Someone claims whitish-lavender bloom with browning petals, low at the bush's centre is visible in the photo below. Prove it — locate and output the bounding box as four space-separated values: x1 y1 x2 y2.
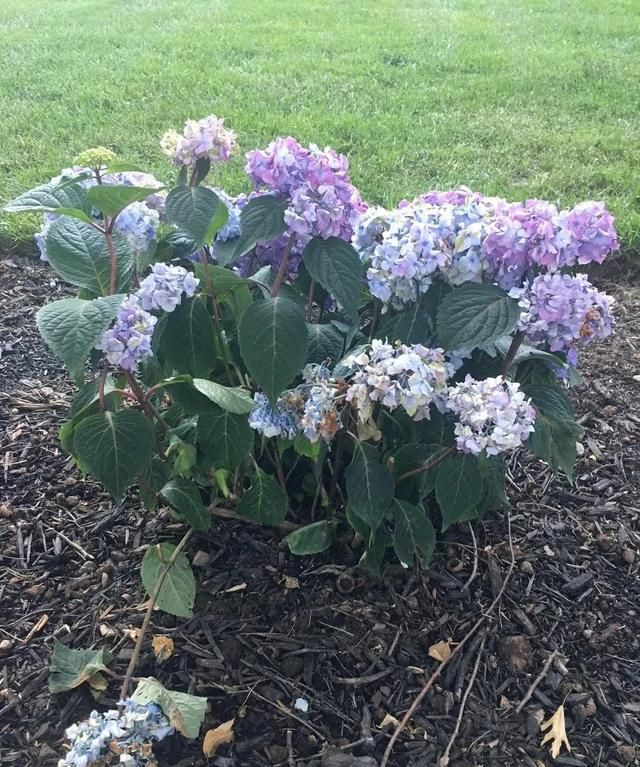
346 339 454 423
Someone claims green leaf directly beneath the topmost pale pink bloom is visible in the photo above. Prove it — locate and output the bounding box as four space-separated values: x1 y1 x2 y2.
166 186 229 247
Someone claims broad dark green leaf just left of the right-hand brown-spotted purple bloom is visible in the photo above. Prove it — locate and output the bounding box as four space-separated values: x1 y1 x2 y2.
438 282 520 349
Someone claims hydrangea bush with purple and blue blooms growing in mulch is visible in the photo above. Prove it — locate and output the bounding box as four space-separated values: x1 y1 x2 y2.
7 115 618 592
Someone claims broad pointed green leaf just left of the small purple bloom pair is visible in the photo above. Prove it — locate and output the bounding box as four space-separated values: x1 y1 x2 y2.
36 295 124 378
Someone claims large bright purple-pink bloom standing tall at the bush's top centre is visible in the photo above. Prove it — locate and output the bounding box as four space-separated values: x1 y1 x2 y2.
246 137 366 245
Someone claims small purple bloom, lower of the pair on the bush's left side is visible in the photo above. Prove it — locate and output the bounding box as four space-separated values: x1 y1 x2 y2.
96 295 157 371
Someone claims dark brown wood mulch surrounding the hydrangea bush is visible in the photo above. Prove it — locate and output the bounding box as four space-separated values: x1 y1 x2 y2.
0 255 640 767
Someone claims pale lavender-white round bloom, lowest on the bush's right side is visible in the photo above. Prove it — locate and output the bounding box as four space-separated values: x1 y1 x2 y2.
446 375 536 455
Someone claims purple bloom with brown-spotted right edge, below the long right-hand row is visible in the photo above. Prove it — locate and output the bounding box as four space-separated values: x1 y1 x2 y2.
511 272 615 365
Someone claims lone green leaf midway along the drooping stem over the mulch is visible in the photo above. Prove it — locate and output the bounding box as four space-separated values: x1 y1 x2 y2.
140 543 196 618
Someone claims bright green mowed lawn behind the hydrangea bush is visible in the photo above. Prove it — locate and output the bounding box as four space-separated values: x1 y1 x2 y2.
0 0 640 249
